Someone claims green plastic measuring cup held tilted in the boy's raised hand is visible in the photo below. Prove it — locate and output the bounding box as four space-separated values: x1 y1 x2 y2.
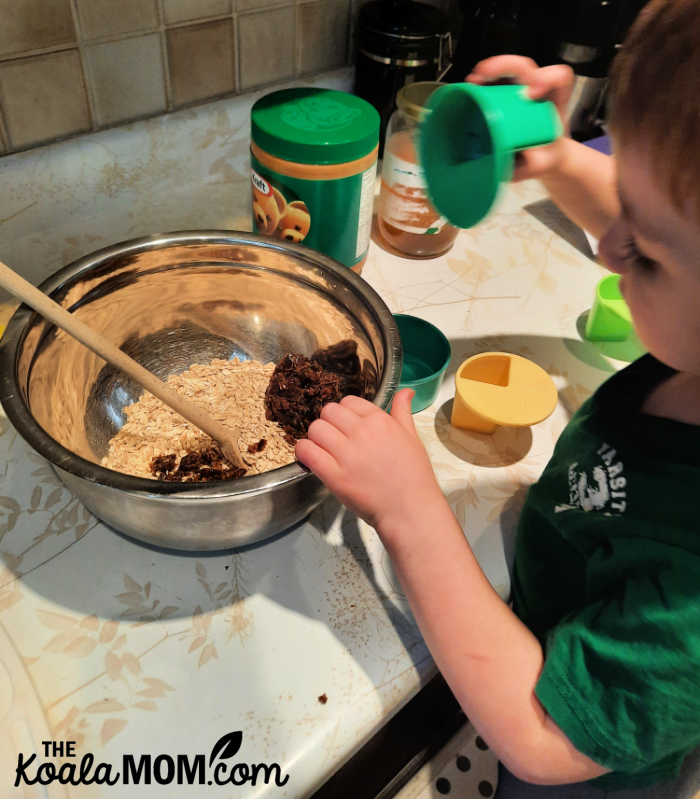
419 83 562 228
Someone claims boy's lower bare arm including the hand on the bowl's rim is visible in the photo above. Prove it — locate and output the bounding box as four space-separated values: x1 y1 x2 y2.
296 390 607 784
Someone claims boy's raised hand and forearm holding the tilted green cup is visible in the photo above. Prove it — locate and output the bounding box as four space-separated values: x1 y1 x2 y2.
467 55 619 239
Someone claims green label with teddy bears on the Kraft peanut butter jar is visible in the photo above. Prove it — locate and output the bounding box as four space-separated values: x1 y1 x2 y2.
250 156 377 267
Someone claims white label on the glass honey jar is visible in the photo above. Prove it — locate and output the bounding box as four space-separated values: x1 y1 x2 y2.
379 148 448 236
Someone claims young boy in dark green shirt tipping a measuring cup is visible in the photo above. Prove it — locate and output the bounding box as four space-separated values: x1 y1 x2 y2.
297 0 700 786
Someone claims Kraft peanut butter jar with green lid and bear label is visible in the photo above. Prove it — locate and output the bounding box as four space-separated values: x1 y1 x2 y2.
250 88 379 272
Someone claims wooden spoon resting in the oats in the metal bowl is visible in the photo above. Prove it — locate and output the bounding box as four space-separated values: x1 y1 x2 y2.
0 261 248 470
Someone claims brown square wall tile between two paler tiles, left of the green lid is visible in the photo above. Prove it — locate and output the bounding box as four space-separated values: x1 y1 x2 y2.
166 19 235 105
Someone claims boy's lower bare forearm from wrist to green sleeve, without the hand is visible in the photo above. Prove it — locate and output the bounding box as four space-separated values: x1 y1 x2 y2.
378 495 608 784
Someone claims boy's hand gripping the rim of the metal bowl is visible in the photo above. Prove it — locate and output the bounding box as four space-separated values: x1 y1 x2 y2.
296 389 442 528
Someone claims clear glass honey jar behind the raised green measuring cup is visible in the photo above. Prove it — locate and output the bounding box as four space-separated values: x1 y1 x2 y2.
377 81 459 258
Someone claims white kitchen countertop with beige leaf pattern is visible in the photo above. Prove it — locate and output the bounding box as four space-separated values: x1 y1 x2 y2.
0 76 619 797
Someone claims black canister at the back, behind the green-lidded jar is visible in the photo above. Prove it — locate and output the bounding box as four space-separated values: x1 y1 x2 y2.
354 0 450 154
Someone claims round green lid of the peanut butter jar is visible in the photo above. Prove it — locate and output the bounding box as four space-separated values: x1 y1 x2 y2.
251 88 379 164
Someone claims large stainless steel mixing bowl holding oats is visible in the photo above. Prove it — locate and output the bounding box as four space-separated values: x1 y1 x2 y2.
0 231 401 550
